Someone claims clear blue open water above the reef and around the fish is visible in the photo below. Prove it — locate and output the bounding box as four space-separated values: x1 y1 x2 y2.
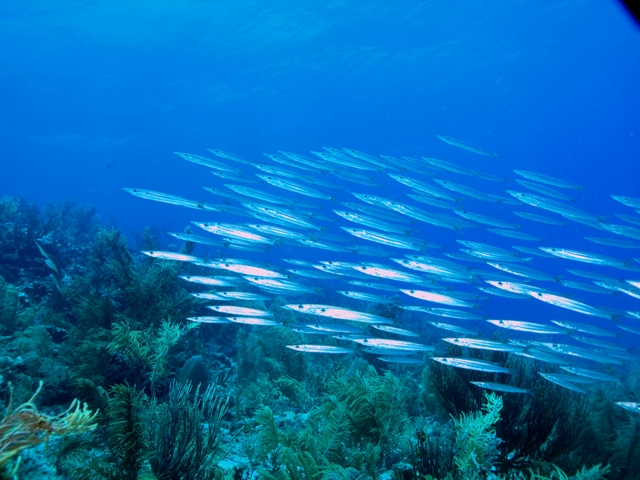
0 0 640 478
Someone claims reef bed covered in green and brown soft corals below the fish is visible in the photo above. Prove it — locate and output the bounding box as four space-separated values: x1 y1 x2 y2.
0 193 640 480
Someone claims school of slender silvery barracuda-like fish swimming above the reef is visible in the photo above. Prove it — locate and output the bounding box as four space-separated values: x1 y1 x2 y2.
124 136 640 413
